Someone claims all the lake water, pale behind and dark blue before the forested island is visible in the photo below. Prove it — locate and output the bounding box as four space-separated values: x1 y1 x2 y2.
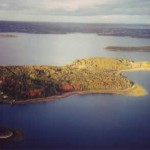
0 33 150 150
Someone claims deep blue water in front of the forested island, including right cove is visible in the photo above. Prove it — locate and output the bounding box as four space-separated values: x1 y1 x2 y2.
0 72 150 150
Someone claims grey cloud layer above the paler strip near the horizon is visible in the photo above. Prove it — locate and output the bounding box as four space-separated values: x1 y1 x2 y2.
0 0 150 16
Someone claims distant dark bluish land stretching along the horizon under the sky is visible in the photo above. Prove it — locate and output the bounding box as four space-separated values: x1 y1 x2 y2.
0 21 150 38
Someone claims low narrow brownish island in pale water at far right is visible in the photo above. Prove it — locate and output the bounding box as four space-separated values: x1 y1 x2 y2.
105 46 150 52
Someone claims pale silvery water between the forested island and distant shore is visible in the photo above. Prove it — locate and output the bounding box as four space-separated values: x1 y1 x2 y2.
0 33 150 65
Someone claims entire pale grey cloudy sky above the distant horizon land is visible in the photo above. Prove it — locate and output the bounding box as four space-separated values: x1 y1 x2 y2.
0 0 150 24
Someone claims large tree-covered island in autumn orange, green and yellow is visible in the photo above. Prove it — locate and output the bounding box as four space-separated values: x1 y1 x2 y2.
0 58 150 104
